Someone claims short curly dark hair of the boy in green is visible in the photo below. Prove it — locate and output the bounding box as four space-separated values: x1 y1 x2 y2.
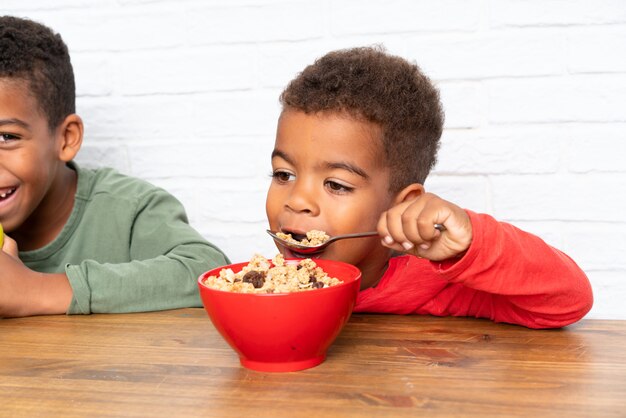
0 16 76 130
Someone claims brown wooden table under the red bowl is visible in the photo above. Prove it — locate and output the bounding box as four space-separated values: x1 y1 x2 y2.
0 309 626 418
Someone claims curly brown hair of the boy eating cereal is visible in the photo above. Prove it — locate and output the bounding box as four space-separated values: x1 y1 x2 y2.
280 47 444 193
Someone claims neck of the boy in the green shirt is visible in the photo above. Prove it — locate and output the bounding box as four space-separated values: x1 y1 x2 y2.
11 164 77 251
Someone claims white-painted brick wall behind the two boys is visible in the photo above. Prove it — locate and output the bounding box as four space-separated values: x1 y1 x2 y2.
0 0 626 319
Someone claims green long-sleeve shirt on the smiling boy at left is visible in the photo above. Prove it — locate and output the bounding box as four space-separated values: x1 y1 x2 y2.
19 163 229 314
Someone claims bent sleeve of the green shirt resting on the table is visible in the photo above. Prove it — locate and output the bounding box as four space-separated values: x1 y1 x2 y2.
65 189 229 314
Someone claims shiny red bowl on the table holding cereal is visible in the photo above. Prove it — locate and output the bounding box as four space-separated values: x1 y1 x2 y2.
198 259 361 372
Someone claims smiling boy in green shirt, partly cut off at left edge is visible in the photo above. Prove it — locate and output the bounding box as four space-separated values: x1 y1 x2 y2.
0 16 229 317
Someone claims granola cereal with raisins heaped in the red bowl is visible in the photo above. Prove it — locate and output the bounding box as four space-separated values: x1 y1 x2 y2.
204 254 343 293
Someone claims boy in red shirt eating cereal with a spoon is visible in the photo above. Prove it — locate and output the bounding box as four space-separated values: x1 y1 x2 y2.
266 48 593 328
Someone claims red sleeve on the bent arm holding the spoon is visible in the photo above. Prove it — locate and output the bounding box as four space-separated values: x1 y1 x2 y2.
418 211 593 328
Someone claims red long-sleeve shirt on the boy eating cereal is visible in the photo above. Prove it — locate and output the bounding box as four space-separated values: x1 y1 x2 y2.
354 211 593 328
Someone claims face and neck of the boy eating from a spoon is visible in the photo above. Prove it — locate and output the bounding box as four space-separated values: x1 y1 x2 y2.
266 110 393 288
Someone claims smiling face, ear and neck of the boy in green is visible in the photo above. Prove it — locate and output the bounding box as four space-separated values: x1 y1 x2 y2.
0 78 82 249
